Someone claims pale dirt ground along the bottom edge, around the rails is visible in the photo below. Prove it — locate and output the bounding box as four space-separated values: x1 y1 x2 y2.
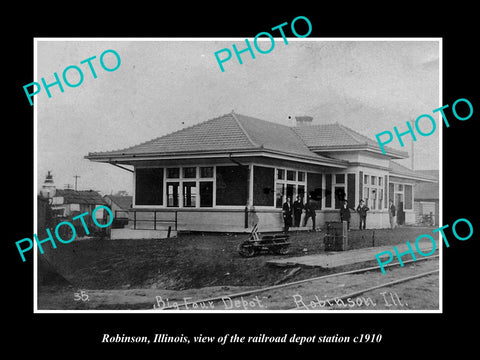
39 258 439 311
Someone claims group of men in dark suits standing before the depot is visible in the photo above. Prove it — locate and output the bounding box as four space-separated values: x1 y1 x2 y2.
282 196 396 232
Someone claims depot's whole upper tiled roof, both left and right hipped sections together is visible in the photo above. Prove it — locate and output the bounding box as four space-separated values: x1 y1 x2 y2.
86 112 408 164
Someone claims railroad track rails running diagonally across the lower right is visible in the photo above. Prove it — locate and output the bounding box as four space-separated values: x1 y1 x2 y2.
160 255 439 310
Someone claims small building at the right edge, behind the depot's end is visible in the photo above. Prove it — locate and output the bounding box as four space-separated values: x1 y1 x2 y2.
414 170 440 226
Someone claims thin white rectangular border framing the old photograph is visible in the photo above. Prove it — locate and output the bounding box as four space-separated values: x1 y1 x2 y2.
33 37 443 314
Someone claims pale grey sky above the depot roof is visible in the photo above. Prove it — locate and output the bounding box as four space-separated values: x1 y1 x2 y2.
36 38 442 194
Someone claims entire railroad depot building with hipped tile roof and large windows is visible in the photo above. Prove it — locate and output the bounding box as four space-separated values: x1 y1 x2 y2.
85 112 436 237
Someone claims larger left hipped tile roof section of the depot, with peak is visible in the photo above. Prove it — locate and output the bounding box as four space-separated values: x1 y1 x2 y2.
86 112 342 163
